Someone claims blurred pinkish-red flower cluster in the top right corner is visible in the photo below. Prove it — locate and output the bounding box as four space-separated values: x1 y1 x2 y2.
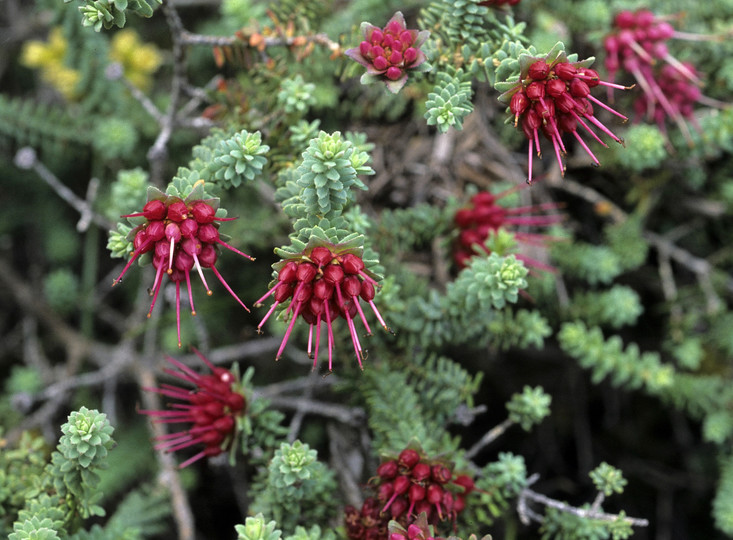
603 9 701 140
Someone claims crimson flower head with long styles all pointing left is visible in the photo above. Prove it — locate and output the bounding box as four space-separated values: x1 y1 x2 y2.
140 349 247 468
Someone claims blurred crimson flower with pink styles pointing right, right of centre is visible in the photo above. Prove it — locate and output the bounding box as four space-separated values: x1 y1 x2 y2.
453 186 564 271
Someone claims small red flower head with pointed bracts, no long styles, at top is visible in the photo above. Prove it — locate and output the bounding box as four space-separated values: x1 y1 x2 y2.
344 11 430 93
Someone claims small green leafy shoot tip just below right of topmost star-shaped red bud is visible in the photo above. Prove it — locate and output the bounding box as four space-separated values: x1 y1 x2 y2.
425 69 473 133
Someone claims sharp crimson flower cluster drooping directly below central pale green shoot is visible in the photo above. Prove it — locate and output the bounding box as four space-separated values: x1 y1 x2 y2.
255 245 389 371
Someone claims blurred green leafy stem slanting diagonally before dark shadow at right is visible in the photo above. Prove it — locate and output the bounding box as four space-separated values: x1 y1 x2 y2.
557 322 675 394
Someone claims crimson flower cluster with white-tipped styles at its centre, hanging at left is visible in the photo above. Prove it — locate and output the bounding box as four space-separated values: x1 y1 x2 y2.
113 197 252 347
